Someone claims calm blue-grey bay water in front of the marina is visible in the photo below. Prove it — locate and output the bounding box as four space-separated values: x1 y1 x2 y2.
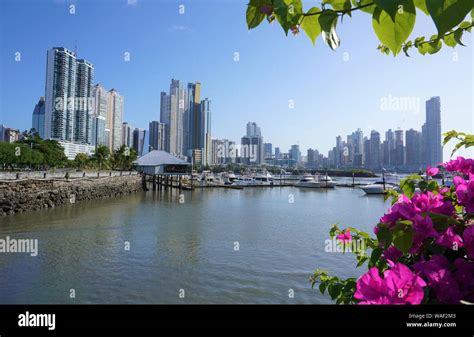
0 187 389 303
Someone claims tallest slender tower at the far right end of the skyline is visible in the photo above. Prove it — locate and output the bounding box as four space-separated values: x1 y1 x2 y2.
422 97 443 166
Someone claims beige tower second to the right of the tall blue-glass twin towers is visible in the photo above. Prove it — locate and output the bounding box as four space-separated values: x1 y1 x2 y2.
106 89 124 150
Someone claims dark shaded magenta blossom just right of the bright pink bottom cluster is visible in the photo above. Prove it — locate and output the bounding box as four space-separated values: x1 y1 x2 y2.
413 255 461 304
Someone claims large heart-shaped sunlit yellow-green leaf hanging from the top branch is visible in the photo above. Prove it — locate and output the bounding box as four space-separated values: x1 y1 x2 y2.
372 0 416 55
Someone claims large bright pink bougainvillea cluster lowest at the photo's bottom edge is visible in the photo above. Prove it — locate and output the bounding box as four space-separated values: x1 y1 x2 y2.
354 263 426 304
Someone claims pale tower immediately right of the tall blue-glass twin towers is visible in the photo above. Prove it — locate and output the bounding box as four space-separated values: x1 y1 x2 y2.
92 84 110 146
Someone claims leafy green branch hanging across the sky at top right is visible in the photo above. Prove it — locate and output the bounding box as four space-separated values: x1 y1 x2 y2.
246 0 474 56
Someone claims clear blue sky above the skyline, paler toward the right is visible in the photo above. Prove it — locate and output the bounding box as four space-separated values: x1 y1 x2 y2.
0 0 474 157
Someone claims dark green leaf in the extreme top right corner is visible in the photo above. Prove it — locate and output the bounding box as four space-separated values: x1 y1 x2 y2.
426 0 474 36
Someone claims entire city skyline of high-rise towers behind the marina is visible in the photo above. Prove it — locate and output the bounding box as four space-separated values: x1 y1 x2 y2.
0 47 443 172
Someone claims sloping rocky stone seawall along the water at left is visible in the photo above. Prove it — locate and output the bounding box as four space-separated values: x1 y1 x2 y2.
0 175 143 216
